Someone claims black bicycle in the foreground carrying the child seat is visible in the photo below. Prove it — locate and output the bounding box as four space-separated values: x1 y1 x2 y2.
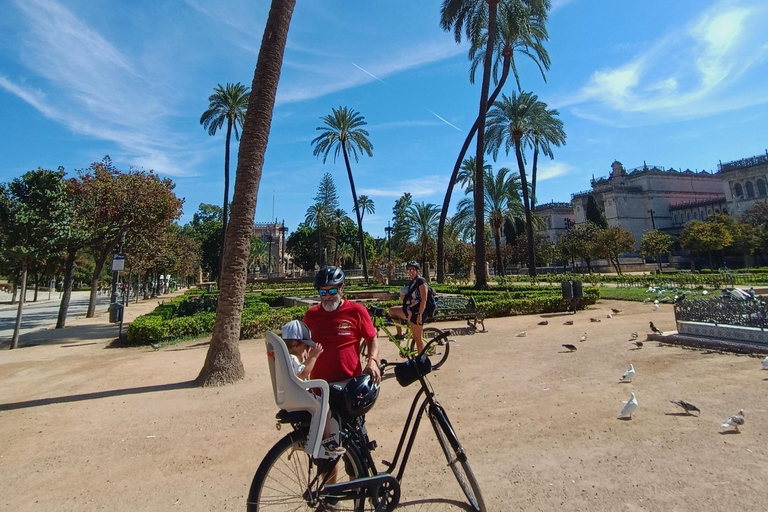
248 333 486 512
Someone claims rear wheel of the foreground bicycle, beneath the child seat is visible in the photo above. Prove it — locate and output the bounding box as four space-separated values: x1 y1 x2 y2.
247 430 374 512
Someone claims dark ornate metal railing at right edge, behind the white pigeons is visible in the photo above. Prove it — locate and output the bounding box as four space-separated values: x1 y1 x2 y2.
675 297 768 330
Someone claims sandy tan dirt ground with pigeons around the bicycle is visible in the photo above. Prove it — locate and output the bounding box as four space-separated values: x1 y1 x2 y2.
0 301 768 512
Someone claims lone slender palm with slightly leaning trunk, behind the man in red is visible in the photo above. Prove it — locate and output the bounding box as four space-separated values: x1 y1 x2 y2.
312 107 373 284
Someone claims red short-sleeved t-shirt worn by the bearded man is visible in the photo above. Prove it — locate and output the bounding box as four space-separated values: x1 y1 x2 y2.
304 300 376 382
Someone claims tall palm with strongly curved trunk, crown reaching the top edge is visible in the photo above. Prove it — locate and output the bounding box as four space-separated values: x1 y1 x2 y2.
437 0 551 282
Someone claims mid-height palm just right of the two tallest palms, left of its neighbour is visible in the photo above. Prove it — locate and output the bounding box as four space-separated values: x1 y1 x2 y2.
487 92 538 276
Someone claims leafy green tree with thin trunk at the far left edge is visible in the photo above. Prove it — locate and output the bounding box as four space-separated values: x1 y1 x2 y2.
0 167 72 349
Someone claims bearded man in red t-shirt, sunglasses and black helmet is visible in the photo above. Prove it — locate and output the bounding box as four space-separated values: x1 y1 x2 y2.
304 266 381 384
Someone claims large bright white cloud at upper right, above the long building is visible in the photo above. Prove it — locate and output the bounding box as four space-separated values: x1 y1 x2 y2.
559 0 768 125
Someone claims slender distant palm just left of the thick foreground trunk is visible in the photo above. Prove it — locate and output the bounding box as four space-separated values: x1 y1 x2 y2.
200 82 250 276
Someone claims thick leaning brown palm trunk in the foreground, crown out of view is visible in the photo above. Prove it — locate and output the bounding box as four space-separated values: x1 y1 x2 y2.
195 0 296 386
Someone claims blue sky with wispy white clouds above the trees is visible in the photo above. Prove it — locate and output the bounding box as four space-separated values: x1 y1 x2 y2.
0 0 768 237
